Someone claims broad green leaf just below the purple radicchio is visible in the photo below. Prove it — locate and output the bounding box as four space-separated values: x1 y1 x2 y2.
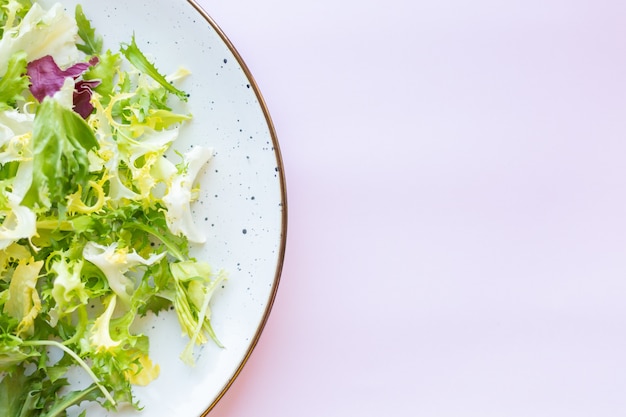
22 97 98 208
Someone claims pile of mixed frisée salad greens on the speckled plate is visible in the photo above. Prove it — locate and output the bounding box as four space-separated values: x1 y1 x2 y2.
0 0 225 417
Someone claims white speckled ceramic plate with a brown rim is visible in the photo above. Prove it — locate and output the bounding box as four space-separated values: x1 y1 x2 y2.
40 0 286 417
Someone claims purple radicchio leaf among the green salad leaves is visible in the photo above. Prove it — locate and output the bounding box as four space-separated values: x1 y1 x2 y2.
26 55 100 118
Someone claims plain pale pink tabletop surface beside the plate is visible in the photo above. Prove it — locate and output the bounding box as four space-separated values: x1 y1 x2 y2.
200 0 626 417
